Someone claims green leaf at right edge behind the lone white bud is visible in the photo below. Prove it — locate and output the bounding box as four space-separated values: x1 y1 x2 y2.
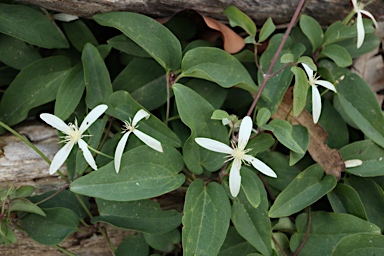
339 140 384 177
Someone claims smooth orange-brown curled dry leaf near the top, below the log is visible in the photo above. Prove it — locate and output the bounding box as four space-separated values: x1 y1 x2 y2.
202 16 245 54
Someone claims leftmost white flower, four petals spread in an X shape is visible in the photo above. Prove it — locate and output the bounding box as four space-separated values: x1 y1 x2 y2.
40 104 108 175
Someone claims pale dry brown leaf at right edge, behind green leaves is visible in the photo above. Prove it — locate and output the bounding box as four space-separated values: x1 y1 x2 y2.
352 22 384 106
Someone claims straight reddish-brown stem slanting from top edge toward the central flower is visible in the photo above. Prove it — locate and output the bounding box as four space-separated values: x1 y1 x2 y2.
247 0 305 116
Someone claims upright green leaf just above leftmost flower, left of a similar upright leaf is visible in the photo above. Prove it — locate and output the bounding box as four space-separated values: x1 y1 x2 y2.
55 64 85 120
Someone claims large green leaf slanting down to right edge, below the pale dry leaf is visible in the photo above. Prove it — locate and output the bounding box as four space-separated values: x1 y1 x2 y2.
337 71 384 147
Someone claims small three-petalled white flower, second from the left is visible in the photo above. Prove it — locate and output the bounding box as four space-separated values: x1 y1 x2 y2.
114 109 163 173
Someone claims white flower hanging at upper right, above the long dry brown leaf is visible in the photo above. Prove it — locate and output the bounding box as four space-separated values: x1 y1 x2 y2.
301 63 336 124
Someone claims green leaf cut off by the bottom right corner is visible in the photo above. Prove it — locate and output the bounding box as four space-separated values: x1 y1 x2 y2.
331 234 384 256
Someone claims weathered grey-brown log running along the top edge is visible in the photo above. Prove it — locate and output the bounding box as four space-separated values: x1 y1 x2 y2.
18 0 384 25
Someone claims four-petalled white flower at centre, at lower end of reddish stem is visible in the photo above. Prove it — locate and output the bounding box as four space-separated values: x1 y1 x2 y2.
195 116 277 197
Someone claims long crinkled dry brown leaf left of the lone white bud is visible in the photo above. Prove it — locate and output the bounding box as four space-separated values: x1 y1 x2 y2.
272 88 345 179
